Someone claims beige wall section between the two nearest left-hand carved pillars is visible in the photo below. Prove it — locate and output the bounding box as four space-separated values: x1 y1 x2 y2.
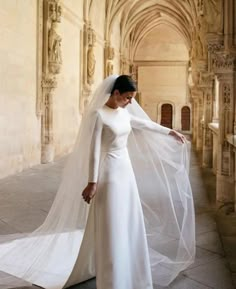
53 0 83 156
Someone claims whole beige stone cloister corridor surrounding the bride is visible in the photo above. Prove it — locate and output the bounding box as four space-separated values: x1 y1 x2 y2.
0 0 236 289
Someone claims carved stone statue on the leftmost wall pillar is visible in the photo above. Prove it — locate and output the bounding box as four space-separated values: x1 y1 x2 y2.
48 22 62 74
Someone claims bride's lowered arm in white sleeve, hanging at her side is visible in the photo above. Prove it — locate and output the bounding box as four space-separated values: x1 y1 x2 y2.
82 113 103 204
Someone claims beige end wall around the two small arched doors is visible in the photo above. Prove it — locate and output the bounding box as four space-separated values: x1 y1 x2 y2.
138 65 188 129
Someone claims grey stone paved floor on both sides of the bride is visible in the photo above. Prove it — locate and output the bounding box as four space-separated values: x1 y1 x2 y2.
0 152 234 289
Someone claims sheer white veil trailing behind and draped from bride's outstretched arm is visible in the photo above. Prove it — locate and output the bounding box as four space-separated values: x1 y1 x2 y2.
0 75 195 289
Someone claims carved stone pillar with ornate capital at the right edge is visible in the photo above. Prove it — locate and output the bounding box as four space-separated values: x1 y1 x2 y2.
212 52 235 204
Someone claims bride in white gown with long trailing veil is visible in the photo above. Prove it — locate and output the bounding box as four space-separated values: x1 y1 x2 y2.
0 75 195 289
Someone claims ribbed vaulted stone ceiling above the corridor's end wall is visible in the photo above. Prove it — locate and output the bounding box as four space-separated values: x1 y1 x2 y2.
105 0 197 59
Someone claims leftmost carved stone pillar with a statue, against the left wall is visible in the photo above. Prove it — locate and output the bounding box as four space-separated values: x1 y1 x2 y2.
39 0 62 163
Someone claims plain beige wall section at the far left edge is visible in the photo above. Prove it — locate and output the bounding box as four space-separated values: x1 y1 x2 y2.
0 0 40 177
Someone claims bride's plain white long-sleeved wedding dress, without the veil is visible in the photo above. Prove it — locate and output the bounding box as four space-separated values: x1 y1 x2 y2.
65 105 170 289
